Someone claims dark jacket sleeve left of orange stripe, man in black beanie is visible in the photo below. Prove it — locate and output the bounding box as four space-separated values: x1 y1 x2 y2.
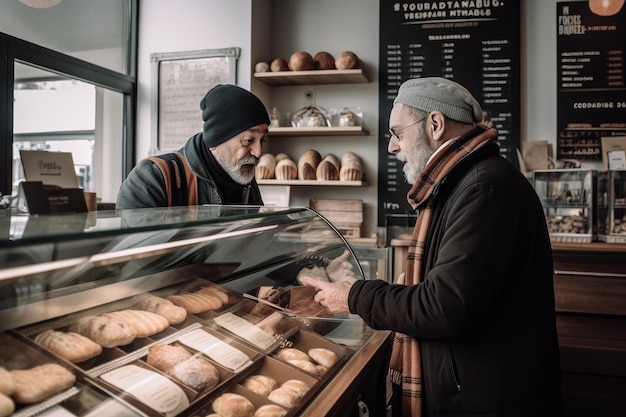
116 160 167 209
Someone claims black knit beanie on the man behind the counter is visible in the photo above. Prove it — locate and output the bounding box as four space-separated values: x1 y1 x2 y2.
200 84 270 148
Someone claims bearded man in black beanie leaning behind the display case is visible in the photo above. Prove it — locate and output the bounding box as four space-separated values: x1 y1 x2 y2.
116 84 270 209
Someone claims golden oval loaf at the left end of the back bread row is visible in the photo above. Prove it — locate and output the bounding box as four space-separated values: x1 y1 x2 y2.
34 330 102 363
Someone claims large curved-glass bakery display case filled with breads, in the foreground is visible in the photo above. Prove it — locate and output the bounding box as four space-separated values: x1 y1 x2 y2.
0 206 390 417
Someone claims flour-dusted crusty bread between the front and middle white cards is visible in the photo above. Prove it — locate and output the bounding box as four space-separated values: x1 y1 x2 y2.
146 345 220 391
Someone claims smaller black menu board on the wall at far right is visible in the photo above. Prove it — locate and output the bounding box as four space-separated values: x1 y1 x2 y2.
557 1 626 161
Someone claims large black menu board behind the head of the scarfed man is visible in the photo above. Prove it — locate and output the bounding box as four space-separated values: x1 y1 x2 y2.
378 0 521 227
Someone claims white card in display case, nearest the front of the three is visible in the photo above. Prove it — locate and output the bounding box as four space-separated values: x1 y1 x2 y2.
100 365 189 417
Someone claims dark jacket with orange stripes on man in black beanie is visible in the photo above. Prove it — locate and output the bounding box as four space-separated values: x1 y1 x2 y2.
116 133 263 209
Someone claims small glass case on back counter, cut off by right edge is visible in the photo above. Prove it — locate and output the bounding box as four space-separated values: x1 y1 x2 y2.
598 170 626 243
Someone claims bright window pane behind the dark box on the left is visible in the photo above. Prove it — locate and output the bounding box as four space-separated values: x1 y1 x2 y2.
12 64 123 202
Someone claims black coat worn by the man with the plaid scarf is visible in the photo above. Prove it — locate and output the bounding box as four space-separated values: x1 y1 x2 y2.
349 145 562 417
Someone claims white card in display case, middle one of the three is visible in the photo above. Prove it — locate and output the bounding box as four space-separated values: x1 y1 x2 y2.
178 329 252 372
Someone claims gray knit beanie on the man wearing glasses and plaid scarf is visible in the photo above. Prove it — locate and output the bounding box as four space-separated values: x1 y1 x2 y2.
393 77 483 124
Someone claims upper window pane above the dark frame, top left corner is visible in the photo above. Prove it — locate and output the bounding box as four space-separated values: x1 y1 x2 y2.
0 0 130 73
